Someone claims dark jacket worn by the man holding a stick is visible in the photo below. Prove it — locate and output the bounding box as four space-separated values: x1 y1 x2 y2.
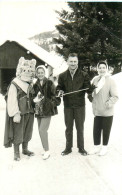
57 69 90 108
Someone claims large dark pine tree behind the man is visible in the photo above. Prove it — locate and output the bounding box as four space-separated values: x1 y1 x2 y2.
55 2 122 71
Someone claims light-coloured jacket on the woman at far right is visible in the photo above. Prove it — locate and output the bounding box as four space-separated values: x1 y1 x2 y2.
92 75 118 116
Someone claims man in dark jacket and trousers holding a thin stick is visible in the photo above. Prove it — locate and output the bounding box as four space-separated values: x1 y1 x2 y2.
57 53 90 156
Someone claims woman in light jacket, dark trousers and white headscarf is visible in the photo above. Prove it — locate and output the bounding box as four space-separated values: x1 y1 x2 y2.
90 61 118 156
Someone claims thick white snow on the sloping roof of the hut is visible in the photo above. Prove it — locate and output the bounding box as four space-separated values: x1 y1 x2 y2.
0 36 62 68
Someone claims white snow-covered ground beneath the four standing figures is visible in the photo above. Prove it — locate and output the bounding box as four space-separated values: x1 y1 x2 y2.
0 73 122 195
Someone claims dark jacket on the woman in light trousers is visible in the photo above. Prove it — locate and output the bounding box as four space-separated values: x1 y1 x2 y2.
33 78 61 117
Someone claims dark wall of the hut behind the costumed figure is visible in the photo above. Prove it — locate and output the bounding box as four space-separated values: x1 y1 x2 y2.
0 41 45 94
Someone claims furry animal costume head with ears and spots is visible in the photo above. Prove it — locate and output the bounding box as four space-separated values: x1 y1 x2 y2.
16 57 36 82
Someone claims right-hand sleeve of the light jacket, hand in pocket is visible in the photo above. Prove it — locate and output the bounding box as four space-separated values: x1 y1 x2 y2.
106 79 119 108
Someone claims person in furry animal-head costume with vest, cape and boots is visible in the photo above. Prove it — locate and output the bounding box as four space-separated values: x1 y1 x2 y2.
4 57 36 161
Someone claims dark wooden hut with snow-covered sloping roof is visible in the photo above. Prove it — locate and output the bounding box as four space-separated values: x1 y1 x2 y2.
0 38 56 94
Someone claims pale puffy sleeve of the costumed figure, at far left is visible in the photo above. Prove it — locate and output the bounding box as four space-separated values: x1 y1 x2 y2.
7 84 20 117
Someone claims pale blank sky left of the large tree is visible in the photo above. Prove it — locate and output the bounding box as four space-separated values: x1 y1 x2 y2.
0 0 67 38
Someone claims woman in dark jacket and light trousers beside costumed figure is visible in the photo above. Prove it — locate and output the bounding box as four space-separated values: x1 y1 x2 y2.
33 65 61 160
